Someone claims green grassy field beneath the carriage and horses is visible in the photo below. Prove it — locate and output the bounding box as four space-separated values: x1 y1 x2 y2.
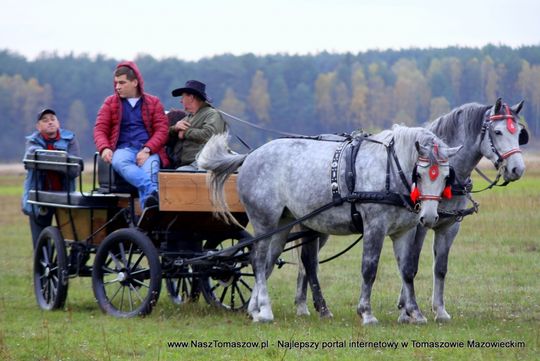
0 166 540 360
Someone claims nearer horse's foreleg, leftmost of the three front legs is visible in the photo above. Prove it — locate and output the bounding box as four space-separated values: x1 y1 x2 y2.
356 227 385 325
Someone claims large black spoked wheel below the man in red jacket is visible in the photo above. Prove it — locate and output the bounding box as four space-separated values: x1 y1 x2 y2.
92 228 161 317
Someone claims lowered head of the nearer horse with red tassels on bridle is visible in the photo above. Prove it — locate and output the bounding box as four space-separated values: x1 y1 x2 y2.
411 137 462 228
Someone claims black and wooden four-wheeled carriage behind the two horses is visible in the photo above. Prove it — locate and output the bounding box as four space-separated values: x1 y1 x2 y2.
24 150 260 317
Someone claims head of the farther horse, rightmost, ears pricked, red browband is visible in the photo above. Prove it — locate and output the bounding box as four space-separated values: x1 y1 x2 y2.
480 98 529 182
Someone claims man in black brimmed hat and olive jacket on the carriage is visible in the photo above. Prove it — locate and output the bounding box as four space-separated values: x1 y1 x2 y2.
169 80 225 171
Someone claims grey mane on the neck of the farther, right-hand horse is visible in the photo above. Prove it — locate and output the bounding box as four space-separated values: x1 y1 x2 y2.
427 103 491 145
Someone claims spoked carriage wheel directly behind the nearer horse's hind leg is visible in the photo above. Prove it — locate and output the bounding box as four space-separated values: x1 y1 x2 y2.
200 231 255 311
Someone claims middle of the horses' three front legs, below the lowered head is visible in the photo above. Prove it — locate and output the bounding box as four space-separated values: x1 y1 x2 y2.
392 227 427 324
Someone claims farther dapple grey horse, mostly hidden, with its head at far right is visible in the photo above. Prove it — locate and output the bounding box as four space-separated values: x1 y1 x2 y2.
295 99 528 322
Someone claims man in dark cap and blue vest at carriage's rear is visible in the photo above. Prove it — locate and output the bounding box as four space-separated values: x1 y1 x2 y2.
21 108 79 248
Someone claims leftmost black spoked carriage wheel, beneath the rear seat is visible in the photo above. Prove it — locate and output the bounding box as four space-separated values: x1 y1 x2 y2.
34 227 68 311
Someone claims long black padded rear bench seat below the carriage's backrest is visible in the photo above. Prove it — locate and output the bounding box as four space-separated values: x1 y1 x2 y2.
28 190 120 208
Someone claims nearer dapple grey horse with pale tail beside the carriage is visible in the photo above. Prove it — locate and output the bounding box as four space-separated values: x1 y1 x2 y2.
198 126 459 324
